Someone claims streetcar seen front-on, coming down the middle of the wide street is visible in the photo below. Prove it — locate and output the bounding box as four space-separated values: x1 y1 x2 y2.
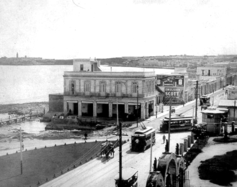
130 127 156 152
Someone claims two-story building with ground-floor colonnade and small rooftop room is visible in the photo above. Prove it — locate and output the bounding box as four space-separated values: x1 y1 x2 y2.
63 59 156 119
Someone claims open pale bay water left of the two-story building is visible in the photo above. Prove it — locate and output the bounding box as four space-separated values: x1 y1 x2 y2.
0 65 73 104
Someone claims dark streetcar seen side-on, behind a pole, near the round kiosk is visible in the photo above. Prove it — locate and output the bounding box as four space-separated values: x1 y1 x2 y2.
160 116 193 132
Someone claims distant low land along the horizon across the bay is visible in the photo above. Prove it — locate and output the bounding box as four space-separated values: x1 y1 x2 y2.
0 55 237 68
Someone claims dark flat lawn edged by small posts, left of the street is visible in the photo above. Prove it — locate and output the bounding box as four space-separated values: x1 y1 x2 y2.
0 142 101 187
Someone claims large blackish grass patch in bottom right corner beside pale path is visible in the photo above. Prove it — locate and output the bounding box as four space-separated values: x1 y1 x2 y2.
198 150 237 186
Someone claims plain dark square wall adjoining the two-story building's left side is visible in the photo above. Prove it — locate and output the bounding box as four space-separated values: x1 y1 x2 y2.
49 94 63 112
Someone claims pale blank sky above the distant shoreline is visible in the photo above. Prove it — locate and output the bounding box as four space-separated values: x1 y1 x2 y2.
0 0 237 59
